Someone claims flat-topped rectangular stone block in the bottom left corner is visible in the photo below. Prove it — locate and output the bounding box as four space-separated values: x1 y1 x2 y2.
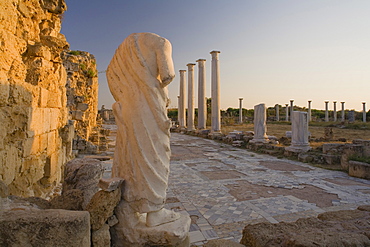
0 209 90 247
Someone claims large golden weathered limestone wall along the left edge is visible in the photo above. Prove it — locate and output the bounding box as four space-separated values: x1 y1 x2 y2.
0 0 73 196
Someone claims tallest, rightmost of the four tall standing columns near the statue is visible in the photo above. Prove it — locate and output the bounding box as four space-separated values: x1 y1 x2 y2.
210 51 221 133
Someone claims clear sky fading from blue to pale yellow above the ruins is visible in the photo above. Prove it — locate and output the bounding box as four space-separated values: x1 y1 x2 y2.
62 0 370 110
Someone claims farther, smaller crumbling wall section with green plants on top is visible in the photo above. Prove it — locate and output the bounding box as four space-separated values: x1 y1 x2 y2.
63 51 98 140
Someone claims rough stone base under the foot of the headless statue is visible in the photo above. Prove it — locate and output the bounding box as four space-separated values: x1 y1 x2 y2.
111 201 190 247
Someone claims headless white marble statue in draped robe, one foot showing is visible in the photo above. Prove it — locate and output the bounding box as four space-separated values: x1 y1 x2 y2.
106 33 180 227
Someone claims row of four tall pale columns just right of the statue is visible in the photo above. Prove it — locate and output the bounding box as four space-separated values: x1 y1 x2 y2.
178 51 221 133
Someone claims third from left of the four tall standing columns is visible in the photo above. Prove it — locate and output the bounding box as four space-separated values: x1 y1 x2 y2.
197 59 207 130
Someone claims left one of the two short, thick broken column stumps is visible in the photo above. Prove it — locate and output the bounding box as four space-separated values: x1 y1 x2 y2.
250 104 268 143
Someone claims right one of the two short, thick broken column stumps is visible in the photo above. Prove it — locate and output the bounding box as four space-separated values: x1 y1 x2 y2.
285 111 311 152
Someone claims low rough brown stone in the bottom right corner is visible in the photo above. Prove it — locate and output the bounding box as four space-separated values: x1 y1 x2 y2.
240 210 370 247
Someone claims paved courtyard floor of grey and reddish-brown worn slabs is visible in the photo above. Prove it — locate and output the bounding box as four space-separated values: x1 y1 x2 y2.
102 128 370 246
